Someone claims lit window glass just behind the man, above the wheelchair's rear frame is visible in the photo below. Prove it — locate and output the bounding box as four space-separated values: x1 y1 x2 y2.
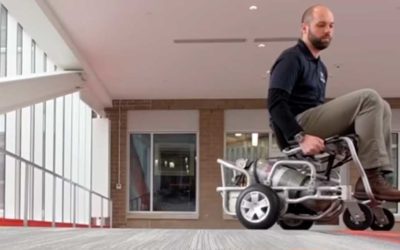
225 132 269 161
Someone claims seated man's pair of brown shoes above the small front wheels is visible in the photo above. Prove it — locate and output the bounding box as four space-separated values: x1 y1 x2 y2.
354 168 400 202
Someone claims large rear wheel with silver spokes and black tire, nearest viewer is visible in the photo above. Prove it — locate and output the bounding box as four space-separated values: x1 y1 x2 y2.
236 184 280 229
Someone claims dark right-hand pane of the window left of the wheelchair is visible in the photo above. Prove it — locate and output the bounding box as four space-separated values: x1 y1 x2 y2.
153 134 196 211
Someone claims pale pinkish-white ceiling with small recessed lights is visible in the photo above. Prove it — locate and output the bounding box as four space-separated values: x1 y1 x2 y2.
39 0 400 99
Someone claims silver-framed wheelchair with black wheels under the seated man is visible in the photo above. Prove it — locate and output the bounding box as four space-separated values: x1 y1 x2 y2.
217 127 395 231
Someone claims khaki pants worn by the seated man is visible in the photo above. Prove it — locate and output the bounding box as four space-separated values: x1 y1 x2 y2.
296 89 393 171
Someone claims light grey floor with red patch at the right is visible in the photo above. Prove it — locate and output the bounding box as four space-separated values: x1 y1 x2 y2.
0 227 400 250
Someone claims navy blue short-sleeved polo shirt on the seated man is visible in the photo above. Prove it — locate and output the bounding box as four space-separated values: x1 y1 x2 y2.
269 39 327 115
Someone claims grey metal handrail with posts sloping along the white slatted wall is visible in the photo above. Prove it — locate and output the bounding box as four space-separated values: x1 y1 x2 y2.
0 147 112 228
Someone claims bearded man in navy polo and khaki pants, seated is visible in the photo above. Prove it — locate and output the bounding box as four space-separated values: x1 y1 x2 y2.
268 5 400 202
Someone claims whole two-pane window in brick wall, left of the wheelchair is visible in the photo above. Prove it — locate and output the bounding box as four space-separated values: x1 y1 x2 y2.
129 134 197 212
